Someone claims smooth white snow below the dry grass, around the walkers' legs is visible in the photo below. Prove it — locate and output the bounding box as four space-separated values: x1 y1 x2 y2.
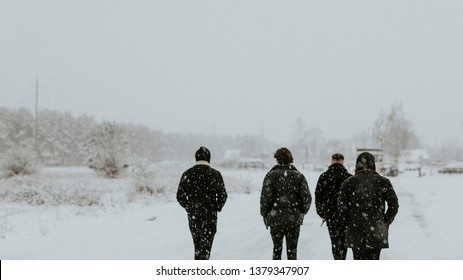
0 171 463 260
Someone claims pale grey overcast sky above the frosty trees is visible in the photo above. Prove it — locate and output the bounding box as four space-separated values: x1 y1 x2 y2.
0 0 463 147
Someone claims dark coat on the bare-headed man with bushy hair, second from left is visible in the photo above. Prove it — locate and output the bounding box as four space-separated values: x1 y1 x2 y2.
260 165 312 226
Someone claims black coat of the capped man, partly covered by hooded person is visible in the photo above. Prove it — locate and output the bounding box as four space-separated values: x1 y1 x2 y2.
315 163 352 219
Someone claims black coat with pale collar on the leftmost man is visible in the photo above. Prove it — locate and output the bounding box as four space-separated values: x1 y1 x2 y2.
177 164 227 221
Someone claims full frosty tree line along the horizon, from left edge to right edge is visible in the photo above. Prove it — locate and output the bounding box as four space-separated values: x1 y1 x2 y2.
0 105 463 176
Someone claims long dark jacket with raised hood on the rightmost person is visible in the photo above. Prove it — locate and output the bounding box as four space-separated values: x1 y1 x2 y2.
338 152 399 249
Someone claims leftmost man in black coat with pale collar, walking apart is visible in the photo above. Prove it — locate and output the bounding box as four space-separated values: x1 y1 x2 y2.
177 147 227 260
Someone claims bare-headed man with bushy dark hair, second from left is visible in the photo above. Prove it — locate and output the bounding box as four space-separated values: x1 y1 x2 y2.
260 148 312 260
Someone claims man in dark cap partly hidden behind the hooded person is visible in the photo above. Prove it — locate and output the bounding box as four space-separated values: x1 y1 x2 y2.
315 153 352 260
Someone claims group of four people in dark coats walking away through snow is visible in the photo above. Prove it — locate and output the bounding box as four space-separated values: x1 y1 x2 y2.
177 147 399 260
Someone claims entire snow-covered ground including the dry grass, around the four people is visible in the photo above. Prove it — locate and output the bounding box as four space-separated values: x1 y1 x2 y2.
0 164 463 260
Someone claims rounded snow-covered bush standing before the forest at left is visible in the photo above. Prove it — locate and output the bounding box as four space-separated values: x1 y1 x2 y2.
85 122 128 178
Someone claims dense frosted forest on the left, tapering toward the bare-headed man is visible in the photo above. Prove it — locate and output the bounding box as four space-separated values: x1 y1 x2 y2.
0 107 276 173
